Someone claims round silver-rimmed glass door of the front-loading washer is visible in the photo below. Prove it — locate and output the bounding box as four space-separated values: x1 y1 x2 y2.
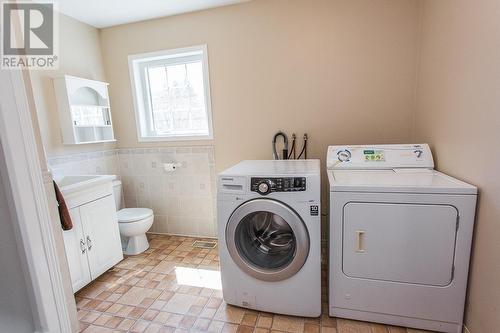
226 199 309 281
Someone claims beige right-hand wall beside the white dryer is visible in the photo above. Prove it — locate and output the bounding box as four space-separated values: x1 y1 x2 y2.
416 0 500 333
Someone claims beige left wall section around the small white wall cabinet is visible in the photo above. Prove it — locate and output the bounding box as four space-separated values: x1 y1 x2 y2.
30 14 114 157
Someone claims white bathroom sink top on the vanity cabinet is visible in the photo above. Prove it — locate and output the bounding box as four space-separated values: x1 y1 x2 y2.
55 175 116 207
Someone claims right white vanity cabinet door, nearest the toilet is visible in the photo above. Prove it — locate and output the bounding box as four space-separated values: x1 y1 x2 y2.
80 195 123 279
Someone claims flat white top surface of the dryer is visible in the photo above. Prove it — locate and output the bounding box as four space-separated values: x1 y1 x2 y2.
328 169 477 194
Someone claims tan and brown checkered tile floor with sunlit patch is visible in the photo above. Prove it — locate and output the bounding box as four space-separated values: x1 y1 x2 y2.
76 235 434 333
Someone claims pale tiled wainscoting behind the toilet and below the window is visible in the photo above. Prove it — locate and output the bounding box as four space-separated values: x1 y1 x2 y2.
49 146 216 237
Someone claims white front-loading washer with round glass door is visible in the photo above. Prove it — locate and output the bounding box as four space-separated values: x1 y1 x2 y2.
217 160 321 317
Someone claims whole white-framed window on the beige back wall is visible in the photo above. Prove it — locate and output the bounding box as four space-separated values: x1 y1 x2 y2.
129 45 212 141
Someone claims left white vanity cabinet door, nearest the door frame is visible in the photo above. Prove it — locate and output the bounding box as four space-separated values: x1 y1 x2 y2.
63 207 91 292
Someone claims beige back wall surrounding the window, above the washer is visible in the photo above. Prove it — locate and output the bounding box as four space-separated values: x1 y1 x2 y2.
101 0 418 170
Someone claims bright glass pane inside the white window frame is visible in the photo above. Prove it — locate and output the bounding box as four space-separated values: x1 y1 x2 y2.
146 61 209 135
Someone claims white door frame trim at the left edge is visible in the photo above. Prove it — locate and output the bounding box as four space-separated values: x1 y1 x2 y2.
0 70 72 333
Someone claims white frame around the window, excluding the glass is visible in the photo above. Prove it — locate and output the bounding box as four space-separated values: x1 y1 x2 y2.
128 44 214 142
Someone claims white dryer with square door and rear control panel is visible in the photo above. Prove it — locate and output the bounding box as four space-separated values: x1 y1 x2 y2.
327 144 477 332
